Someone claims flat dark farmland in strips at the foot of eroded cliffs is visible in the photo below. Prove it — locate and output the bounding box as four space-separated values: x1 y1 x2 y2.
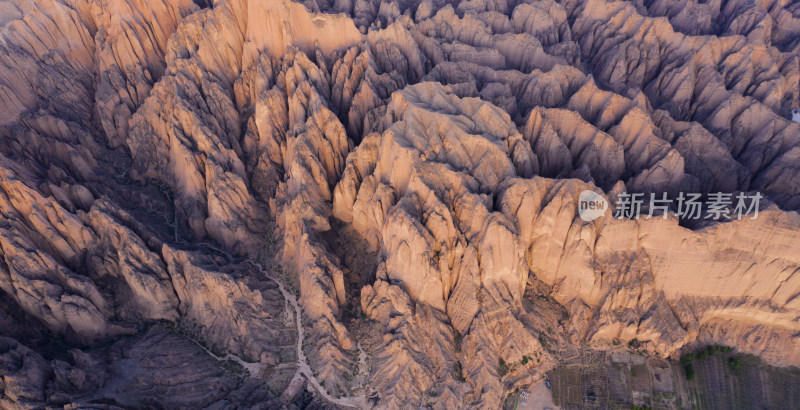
548 351 800 410
